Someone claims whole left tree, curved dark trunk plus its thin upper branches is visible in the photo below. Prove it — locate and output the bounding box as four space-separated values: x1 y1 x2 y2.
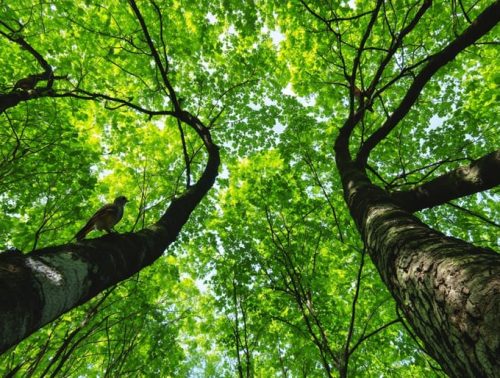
0 1 220 351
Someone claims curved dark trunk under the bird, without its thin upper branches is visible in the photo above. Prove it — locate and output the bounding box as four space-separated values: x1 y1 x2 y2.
0 112 220 353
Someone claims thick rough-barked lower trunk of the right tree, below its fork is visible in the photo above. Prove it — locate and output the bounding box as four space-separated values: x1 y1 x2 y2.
337 158 500 377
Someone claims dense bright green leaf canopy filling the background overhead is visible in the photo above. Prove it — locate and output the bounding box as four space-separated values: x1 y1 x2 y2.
0 0 500 377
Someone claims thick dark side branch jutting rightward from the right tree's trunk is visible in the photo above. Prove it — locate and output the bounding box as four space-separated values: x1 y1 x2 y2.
391 150 500 213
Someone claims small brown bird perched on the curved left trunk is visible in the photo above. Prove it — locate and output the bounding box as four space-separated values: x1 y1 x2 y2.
75 196 128 241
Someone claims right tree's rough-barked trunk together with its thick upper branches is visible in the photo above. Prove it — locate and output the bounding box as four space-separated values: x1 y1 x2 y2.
335 1 500 378
